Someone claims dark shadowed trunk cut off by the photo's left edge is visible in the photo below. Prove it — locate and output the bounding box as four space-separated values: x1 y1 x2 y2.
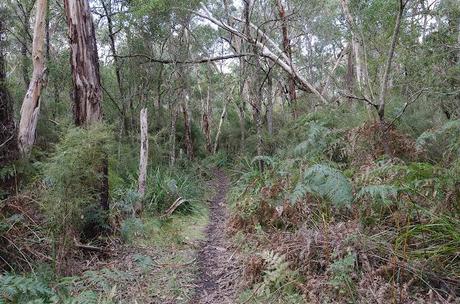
0 6 18 167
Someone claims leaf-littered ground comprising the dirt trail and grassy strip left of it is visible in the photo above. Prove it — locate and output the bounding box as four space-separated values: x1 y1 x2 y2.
58 169 242 304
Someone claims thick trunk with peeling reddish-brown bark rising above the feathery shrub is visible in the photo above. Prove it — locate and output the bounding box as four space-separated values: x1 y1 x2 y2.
64 0 102 126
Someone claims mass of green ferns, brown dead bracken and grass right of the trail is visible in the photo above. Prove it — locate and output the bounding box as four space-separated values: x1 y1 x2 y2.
229 115 460 303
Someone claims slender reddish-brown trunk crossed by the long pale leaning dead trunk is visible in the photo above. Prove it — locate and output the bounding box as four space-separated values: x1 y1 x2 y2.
276 0 297 118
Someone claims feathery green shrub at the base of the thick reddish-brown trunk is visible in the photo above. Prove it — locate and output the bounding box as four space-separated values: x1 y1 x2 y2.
41 124 113 242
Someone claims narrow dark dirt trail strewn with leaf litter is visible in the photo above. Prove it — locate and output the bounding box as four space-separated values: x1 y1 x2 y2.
190 169 242 304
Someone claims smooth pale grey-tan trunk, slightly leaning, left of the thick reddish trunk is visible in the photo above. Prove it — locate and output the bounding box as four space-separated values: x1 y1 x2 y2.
18 0 47 155
